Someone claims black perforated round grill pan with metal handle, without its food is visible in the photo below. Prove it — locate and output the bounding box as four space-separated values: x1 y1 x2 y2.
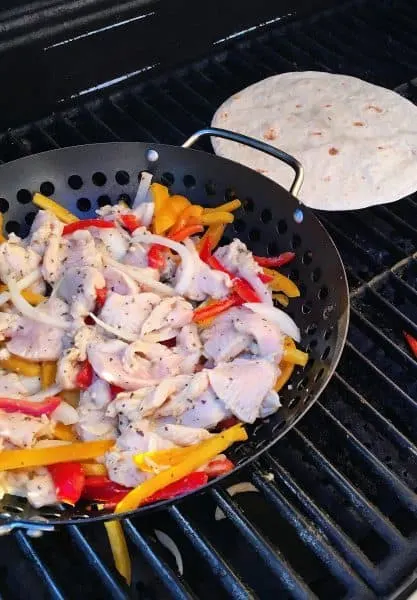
0 129 349 528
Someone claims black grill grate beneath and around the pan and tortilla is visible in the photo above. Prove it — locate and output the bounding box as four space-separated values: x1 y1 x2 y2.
0 1 417 600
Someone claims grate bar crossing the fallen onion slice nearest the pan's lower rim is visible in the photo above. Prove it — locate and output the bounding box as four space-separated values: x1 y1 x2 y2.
211 489 316 600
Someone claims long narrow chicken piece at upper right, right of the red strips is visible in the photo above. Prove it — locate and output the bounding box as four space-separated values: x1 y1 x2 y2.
215 239 272 306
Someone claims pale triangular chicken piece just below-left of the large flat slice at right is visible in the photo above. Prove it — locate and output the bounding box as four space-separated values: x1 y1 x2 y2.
177 388 232 429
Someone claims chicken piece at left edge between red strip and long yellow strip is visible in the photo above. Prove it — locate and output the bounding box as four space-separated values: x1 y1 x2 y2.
0 411 52 448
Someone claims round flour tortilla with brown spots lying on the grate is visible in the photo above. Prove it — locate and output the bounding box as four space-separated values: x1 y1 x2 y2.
212 72 417 210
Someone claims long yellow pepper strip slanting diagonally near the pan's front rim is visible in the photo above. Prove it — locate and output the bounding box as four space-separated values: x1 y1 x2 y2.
114 424 248 513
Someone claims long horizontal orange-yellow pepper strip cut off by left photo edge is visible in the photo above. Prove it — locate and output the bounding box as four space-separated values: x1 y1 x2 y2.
0 440 114 471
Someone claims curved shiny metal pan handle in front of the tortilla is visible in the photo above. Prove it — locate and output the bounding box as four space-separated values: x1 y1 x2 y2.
182 127 304 197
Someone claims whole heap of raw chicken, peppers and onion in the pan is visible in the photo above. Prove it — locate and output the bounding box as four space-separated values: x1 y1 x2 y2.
0 183 308 512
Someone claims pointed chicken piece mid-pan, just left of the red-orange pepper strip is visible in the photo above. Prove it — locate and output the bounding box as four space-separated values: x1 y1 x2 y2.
141 296 193 336
